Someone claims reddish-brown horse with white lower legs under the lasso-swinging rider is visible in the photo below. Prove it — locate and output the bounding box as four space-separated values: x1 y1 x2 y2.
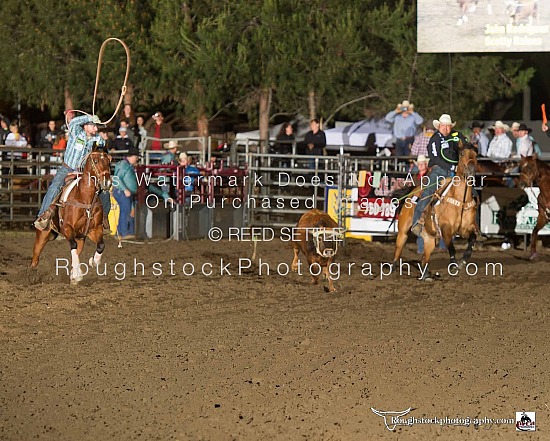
31 150 111 285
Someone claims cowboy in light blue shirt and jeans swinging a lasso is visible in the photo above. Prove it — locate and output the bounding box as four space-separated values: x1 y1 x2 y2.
34 115 111 231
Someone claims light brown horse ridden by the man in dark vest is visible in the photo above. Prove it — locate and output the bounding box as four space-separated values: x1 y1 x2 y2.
393 144 479 279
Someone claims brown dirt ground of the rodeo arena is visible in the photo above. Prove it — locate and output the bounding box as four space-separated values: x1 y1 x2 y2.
0 232 550 441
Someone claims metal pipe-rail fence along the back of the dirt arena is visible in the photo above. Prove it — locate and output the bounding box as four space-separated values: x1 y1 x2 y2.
0 142 548 239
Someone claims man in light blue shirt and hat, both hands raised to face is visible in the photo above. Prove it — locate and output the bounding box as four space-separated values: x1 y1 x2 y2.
385 100 424 156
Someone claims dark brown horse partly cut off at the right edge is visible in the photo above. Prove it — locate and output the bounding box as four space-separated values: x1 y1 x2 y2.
519 154 550 259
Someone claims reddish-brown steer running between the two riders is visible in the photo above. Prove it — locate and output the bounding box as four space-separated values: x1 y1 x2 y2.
292 209 343 292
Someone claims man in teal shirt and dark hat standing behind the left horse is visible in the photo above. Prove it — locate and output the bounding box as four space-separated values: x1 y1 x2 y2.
113 146 139 239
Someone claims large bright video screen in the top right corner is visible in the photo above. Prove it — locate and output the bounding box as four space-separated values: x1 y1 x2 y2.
417 0 550 53
